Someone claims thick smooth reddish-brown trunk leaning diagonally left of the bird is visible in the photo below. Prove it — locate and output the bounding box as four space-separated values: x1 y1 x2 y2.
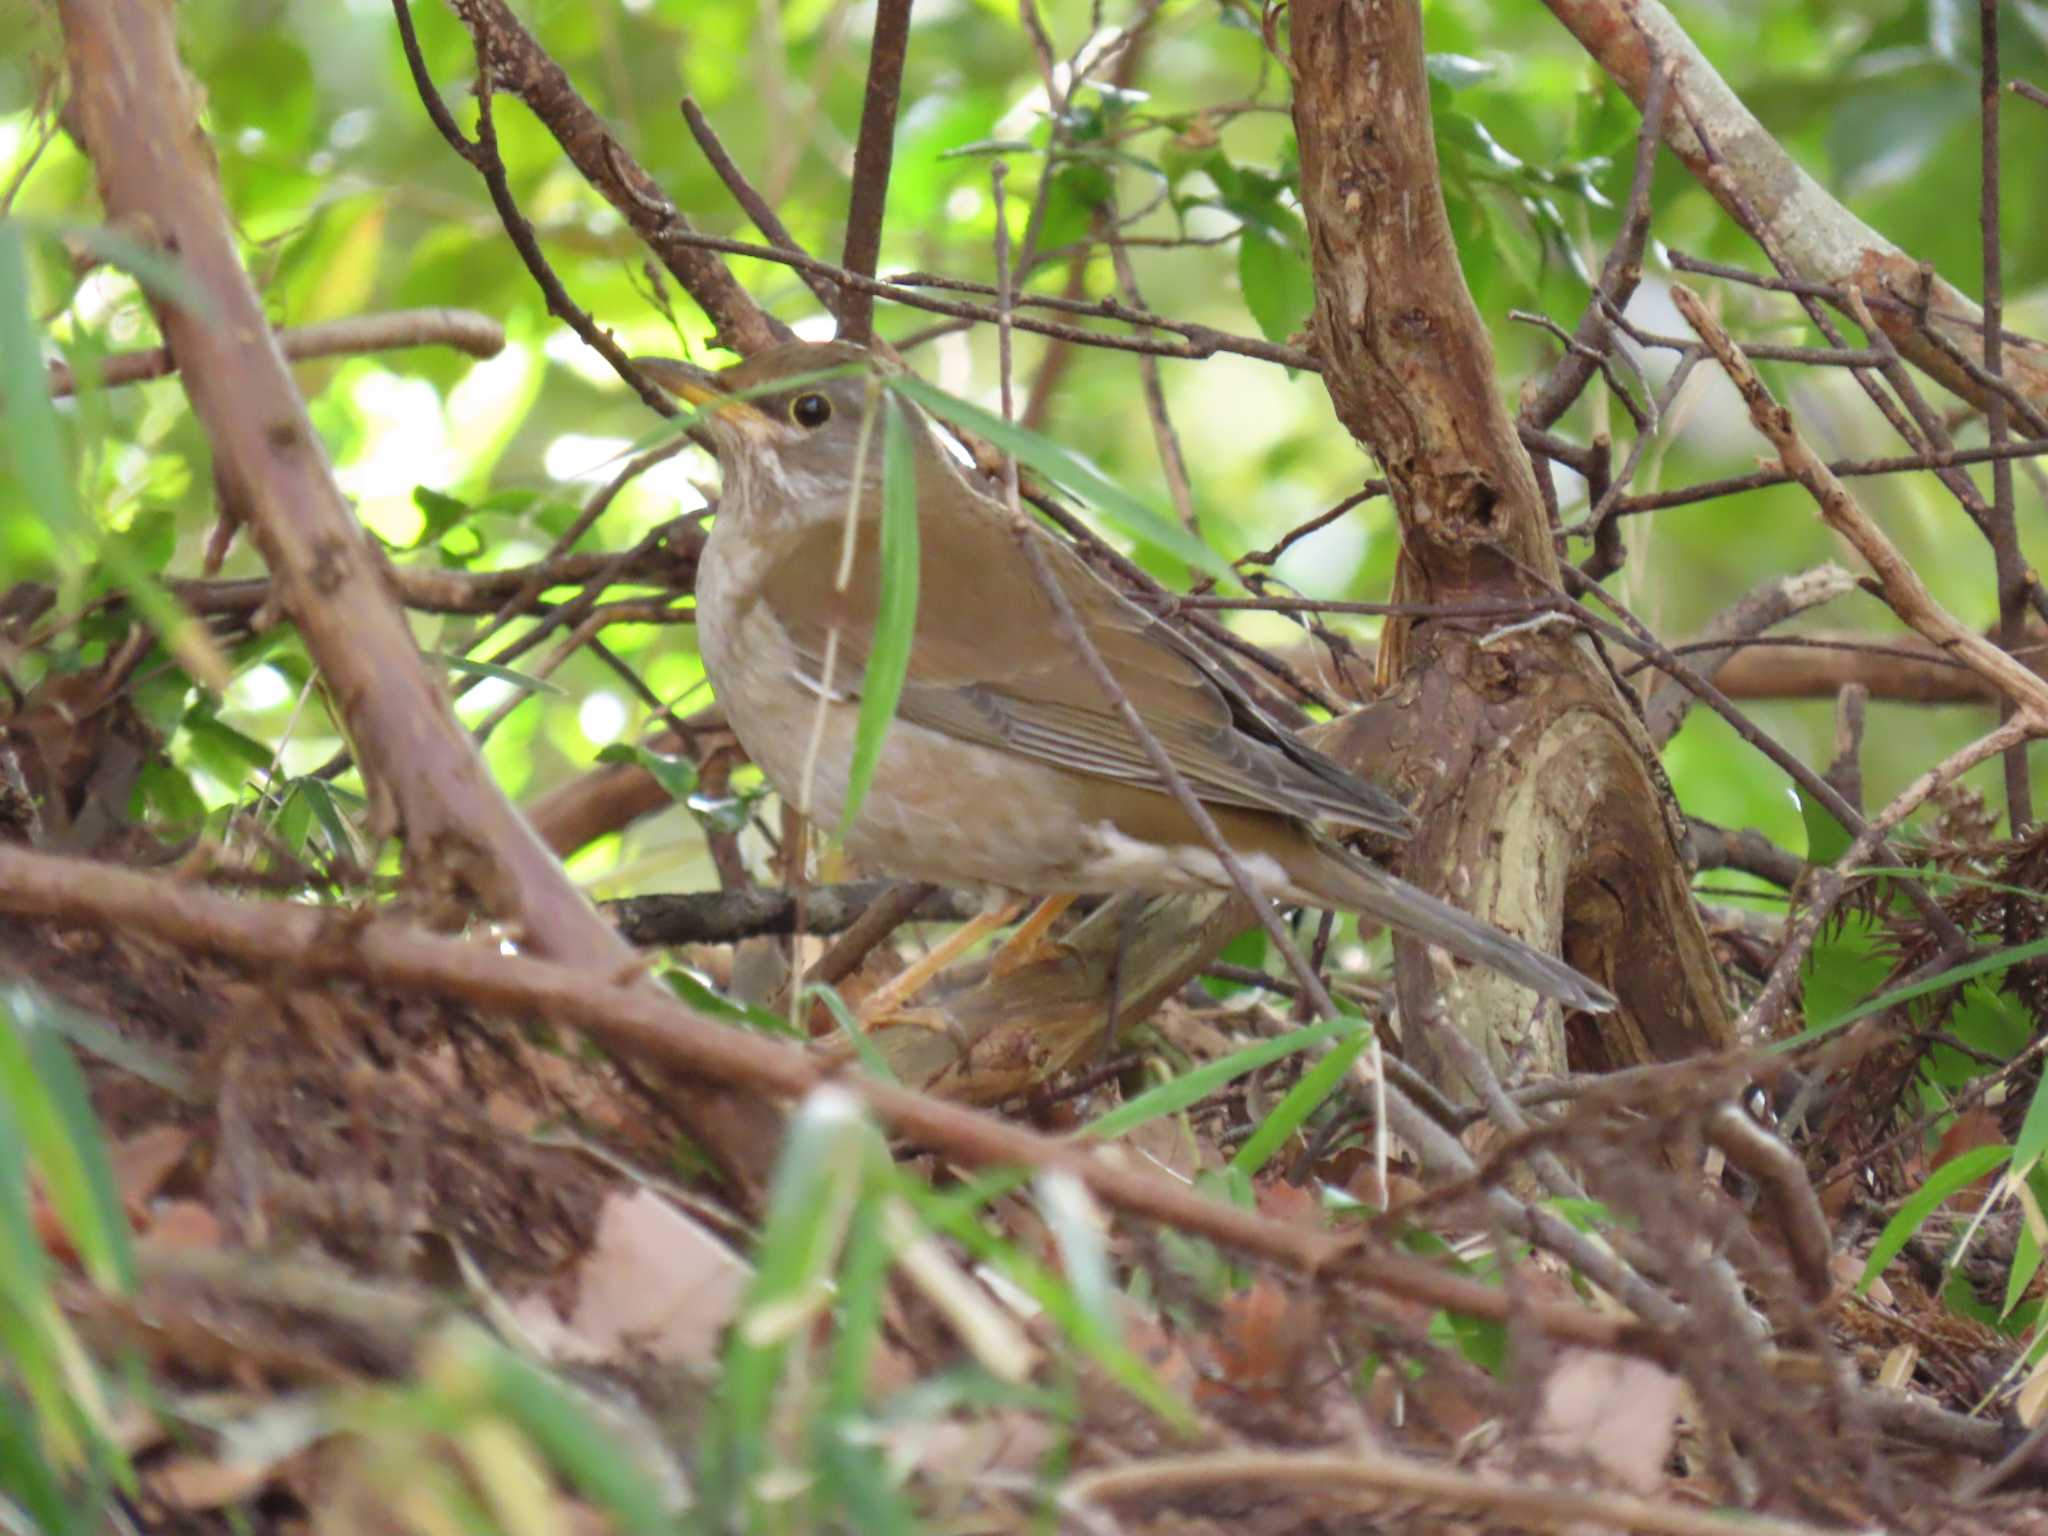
57 0 774 1182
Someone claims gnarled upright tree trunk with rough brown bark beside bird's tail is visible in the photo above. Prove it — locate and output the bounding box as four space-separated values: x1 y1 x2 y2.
1292 0 1733 1092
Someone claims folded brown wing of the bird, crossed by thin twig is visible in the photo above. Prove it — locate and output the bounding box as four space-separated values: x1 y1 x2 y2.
760 467 1413 838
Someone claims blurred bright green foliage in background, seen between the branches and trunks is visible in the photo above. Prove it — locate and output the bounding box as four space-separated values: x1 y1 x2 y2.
0 0 2048 893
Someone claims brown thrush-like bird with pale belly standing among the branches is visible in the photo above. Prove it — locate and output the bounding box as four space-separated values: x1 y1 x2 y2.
635 342 1616 1012
